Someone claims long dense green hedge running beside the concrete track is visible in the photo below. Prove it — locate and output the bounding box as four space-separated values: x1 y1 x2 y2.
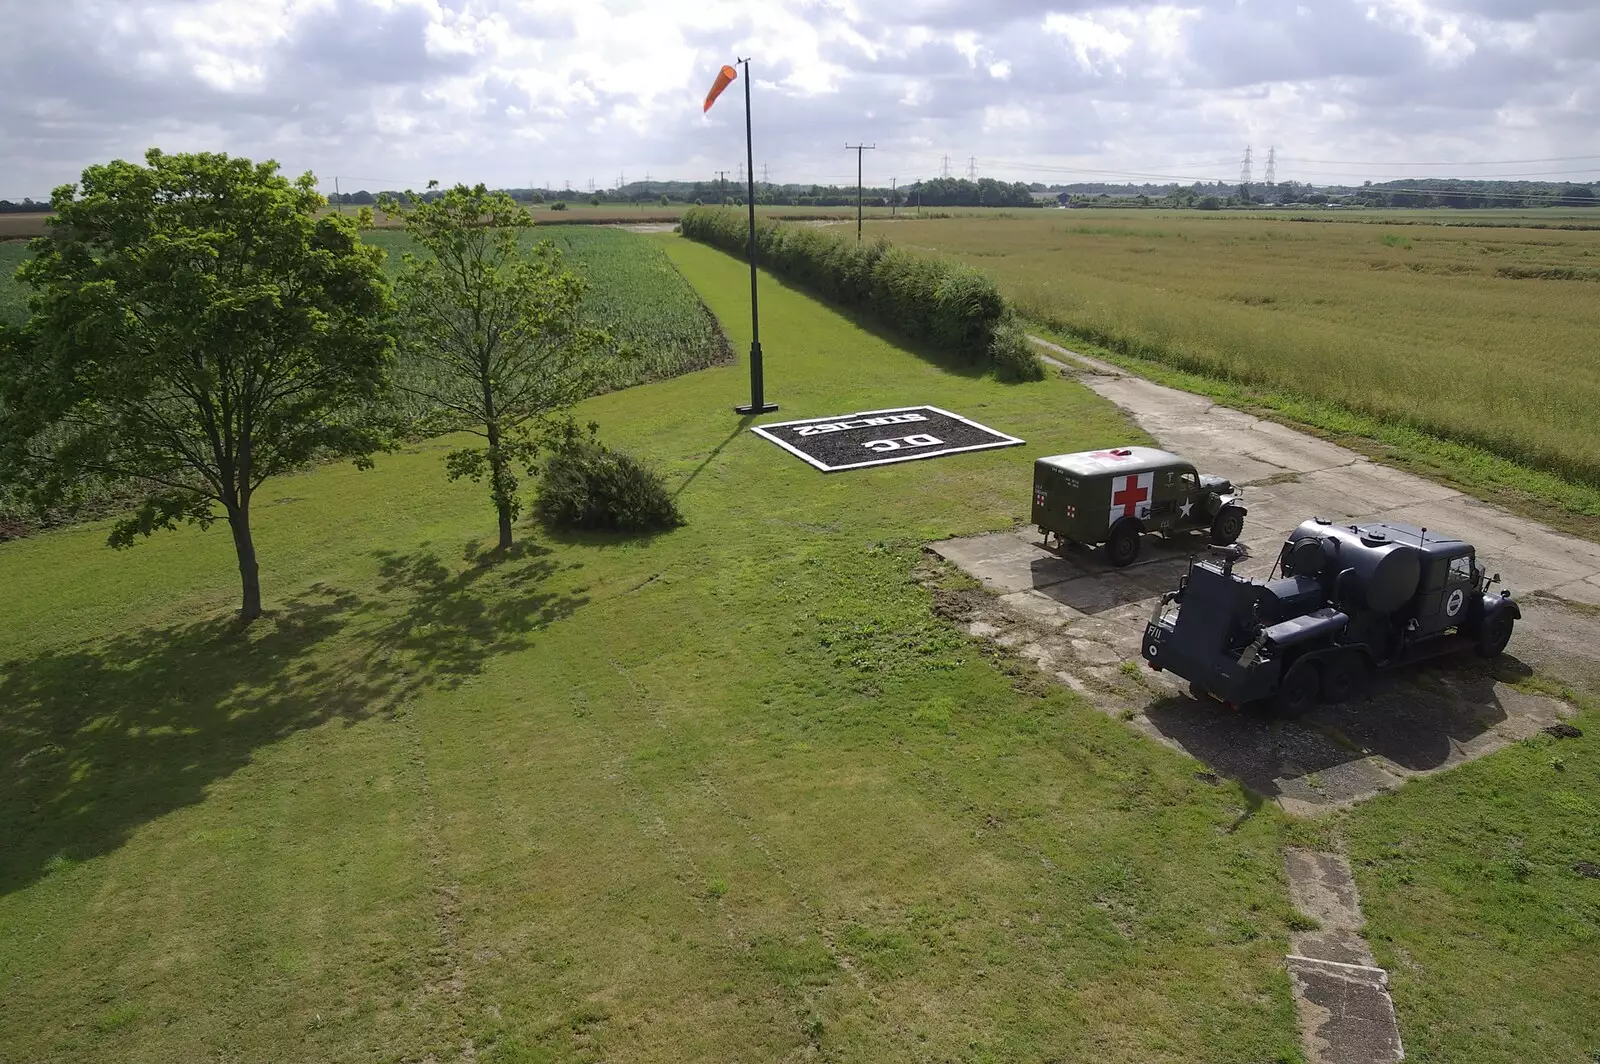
680 208 1045 381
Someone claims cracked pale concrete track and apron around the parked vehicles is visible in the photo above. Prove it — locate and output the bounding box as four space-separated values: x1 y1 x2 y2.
931 341 1600 814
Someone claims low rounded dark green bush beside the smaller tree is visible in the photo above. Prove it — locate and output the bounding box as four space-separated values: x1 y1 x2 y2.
533 422 683 533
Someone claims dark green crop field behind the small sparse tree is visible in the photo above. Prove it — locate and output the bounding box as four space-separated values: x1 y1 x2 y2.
365 226 733 396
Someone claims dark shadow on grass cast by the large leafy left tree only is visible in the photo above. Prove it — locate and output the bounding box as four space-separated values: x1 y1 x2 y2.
0 587 379 894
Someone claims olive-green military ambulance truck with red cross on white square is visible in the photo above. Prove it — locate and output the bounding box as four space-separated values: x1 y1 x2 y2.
1032 446 1246 566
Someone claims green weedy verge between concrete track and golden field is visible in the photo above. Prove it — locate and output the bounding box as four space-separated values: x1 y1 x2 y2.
1026 320 1600 542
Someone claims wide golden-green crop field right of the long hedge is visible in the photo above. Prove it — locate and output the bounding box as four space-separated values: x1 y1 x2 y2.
870 210 1600 499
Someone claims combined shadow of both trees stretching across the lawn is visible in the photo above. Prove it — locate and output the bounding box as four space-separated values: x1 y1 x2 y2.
0 546 587 896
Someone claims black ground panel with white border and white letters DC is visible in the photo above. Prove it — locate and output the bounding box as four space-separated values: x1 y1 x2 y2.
752 406 1022 474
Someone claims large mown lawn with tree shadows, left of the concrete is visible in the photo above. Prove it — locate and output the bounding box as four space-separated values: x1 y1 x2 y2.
0 238 1298 1064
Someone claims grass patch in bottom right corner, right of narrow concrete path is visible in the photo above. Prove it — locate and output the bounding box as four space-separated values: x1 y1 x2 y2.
1338 681 1600 1064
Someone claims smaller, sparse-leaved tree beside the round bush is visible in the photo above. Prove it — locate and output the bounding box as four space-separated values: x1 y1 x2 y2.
384 184 605 550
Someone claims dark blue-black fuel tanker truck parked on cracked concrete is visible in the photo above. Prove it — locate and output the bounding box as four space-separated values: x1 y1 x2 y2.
1141 517 1522 714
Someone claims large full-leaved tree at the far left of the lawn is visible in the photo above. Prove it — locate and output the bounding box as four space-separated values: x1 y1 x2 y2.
0 149 392 621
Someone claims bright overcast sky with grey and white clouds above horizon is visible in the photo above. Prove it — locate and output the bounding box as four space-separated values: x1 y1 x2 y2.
0 0 1600 198
